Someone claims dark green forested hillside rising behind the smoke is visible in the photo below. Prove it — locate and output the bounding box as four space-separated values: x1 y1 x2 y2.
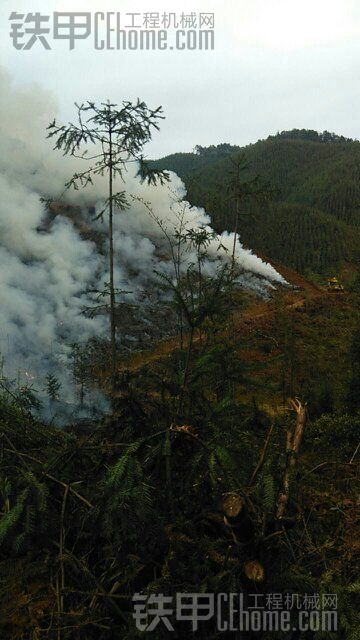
155 130 360 277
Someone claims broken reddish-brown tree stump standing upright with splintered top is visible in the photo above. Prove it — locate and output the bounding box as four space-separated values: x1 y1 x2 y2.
276 400 307 520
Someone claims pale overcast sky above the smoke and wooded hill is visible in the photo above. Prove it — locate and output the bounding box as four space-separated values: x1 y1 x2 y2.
0 0 360 157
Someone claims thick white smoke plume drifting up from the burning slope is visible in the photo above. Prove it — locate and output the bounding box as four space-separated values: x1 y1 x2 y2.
0 70 283 410
